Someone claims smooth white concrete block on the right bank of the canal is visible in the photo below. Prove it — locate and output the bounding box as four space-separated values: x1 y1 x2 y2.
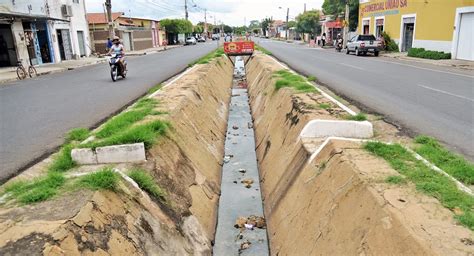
300 120 374 139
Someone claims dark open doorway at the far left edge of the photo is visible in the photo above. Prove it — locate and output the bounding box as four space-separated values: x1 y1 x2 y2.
0 24 17 67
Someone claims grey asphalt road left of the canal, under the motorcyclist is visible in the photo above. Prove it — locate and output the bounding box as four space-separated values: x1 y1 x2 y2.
0 43 216 181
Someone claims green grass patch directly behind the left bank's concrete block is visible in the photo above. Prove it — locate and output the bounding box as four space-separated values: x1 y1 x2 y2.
84 120 170 149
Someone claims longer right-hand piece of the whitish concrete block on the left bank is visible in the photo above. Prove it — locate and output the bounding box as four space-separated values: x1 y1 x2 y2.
96 143 146 164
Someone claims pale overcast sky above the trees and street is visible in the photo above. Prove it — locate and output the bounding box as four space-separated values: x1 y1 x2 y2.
86 0 323 26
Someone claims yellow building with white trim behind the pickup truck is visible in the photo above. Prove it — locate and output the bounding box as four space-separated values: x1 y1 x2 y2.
358 0 474 60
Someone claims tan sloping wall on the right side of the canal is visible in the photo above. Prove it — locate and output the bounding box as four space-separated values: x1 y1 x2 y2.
247 54 474 255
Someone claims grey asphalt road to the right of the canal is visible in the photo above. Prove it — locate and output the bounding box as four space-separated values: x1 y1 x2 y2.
260 40 474 160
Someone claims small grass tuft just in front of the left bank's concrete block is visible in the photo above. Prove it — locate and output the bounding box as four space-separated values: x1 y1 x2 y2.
77 167 120 191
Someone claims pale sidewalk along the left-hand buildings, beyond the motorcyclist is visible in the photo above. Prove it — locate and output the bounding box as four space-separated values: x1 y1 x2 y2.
0 45 181 86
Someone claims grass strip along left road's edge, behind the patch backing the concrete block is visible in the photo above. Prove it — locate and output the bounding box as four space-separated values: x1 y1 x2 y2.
95 98 158 139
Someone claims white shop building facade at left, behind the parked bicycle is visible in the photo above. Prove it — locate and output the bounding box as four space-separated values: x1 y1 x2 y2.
0 0 90 67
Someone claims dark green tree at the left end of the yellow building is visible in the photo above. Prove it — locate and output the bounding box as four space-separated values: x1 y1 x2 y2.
323 0 359 31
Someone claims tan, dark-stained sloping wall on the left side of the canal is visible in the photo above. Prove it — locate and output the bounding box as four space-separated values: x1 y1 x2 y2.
0 57 233 255
